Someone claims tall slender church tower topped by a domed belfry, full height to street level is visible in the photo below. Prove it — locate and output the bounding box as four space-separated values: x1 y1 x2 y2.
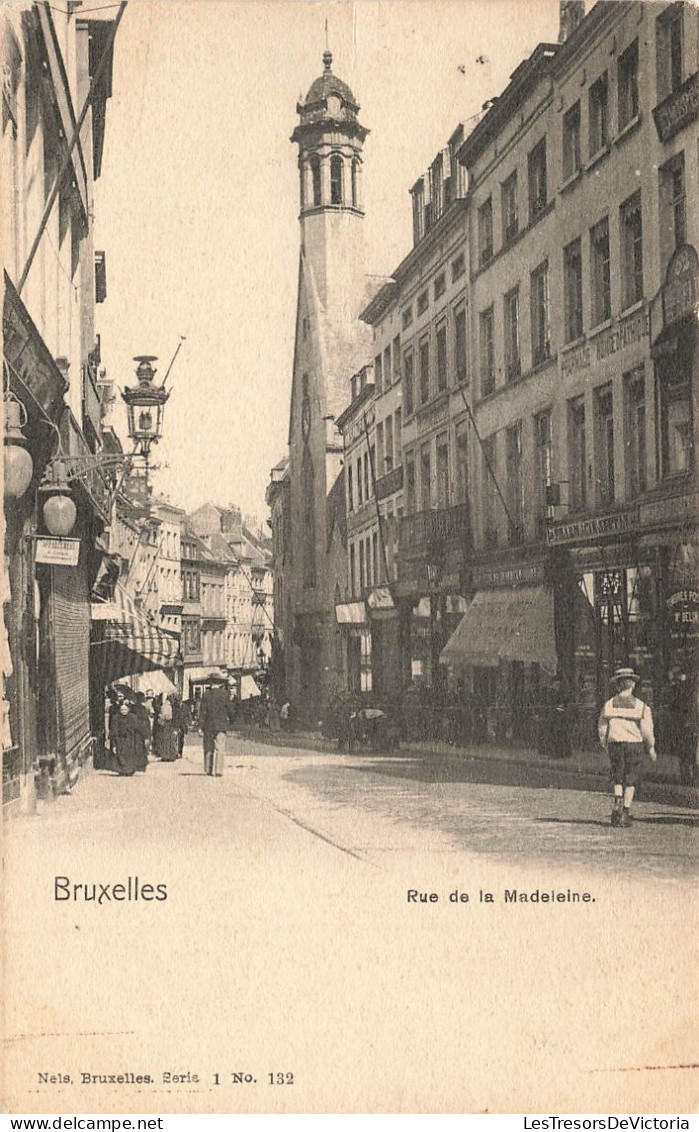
284 51 370 722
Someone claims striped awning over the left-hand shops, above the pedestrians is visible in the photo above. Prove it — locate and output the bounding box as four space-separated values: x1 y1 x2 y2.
91 583 179 687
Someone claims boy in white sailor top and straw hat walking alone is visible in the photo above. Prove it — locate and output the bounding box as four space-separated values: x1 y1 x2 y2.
597 668 657 826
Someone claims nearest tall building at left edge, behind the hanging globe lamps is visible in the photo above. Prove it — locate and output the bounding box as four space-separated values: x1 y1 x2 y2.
0 3 122 806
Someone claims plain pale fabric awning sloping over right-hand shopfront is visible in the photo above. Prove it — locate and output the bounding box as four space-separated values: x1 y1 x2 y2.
440 585 556 672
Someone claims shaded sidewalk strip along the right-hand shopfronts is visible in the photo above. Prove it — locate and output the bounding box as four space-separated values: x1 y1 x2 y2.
237 724 699 809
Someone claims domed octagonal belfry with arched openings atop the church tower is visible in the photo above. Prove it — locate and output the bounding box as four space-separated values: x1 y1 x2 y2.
291 51 369 216
